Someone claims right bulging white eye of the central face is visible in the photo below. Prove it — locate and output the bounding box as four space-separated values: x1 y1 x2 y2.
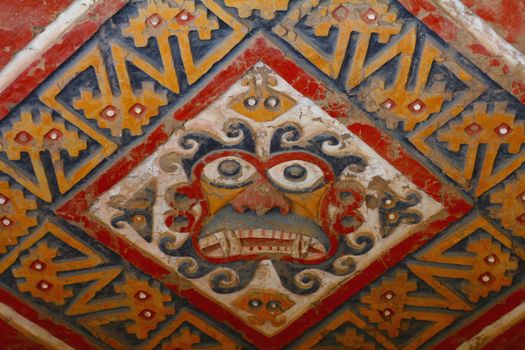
268 160 324 192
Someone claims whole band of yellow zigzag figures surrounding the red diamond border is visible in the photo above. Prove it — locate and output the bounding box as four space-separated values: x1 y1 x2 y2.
0 0 525 349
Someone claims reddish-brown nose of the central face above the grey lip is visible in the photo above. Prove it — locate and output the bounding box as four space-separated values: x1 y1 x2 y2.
230 177 290 215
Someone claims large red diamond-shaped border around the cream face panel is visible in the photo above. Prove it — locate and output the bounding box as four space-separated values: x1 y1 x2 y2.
56 36 472 349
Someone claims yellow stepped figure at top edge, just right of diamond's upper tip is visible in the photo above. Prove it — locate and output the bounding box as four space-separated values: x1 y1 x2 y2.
273 0 401 83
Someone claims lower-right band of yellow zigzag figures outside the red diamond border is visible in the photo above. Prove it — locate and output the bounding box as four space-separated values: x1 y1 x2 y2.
296 217 524 349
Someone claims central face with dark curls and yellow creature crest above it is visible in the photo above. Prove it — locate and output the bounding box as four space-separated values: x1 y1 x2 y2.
161 65 366 264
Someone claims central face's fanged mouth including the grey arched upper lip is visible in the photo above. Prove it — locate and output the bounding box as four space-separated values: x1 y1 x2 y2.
197 206 330 263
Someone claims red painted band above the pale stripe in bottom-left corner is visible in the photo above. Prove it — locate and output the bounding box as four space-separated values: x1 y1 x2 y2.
0 288 98 350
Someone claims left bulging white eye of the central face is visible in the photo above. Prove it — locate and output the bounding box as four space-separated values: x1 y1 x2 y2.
202 156 257 188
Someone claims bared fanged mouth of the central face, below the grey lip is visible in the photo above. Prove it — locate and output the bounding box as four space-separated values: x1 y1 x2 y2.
199 229 326 260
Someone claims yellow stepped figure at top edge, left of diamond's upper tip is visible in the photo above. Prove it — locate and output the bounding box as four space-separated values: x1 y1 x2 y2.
121 0 246 86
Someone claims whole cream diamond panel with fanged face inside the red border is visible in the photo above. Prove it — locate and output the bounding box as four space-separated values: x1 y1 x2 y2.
91 63 443 334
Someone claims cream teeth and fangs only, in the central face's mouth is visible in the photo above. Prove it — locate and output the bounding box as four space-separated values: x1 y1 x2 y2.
199 229 325 258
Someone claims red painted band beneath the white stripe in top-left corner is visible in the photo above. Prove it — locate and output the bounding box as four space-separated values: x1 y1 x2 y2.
0 0 128 120
